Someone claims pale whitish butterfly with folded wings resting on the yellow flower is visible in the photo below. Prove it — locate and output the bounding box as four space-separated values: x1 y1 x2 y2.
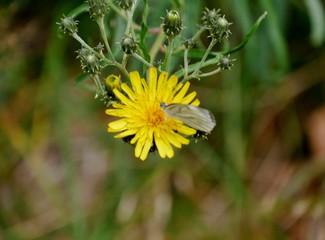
160 102 216 133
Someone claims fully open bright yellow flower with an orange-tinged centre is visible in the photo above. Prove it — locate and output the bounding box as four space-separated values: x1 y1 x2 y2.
106 68 200 160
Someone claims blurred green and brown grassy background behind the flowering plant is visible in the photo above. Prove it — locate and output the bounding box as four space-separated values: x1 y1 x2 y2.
0 0 325 240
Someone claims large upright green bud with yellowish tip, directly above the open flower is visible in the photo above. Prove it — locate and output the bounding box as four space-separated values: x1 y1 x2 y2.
161 10 183 38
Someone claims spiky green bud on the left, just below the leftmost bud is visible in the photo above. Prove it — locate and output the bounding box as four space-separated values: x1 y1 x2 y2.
77 48 102 74
